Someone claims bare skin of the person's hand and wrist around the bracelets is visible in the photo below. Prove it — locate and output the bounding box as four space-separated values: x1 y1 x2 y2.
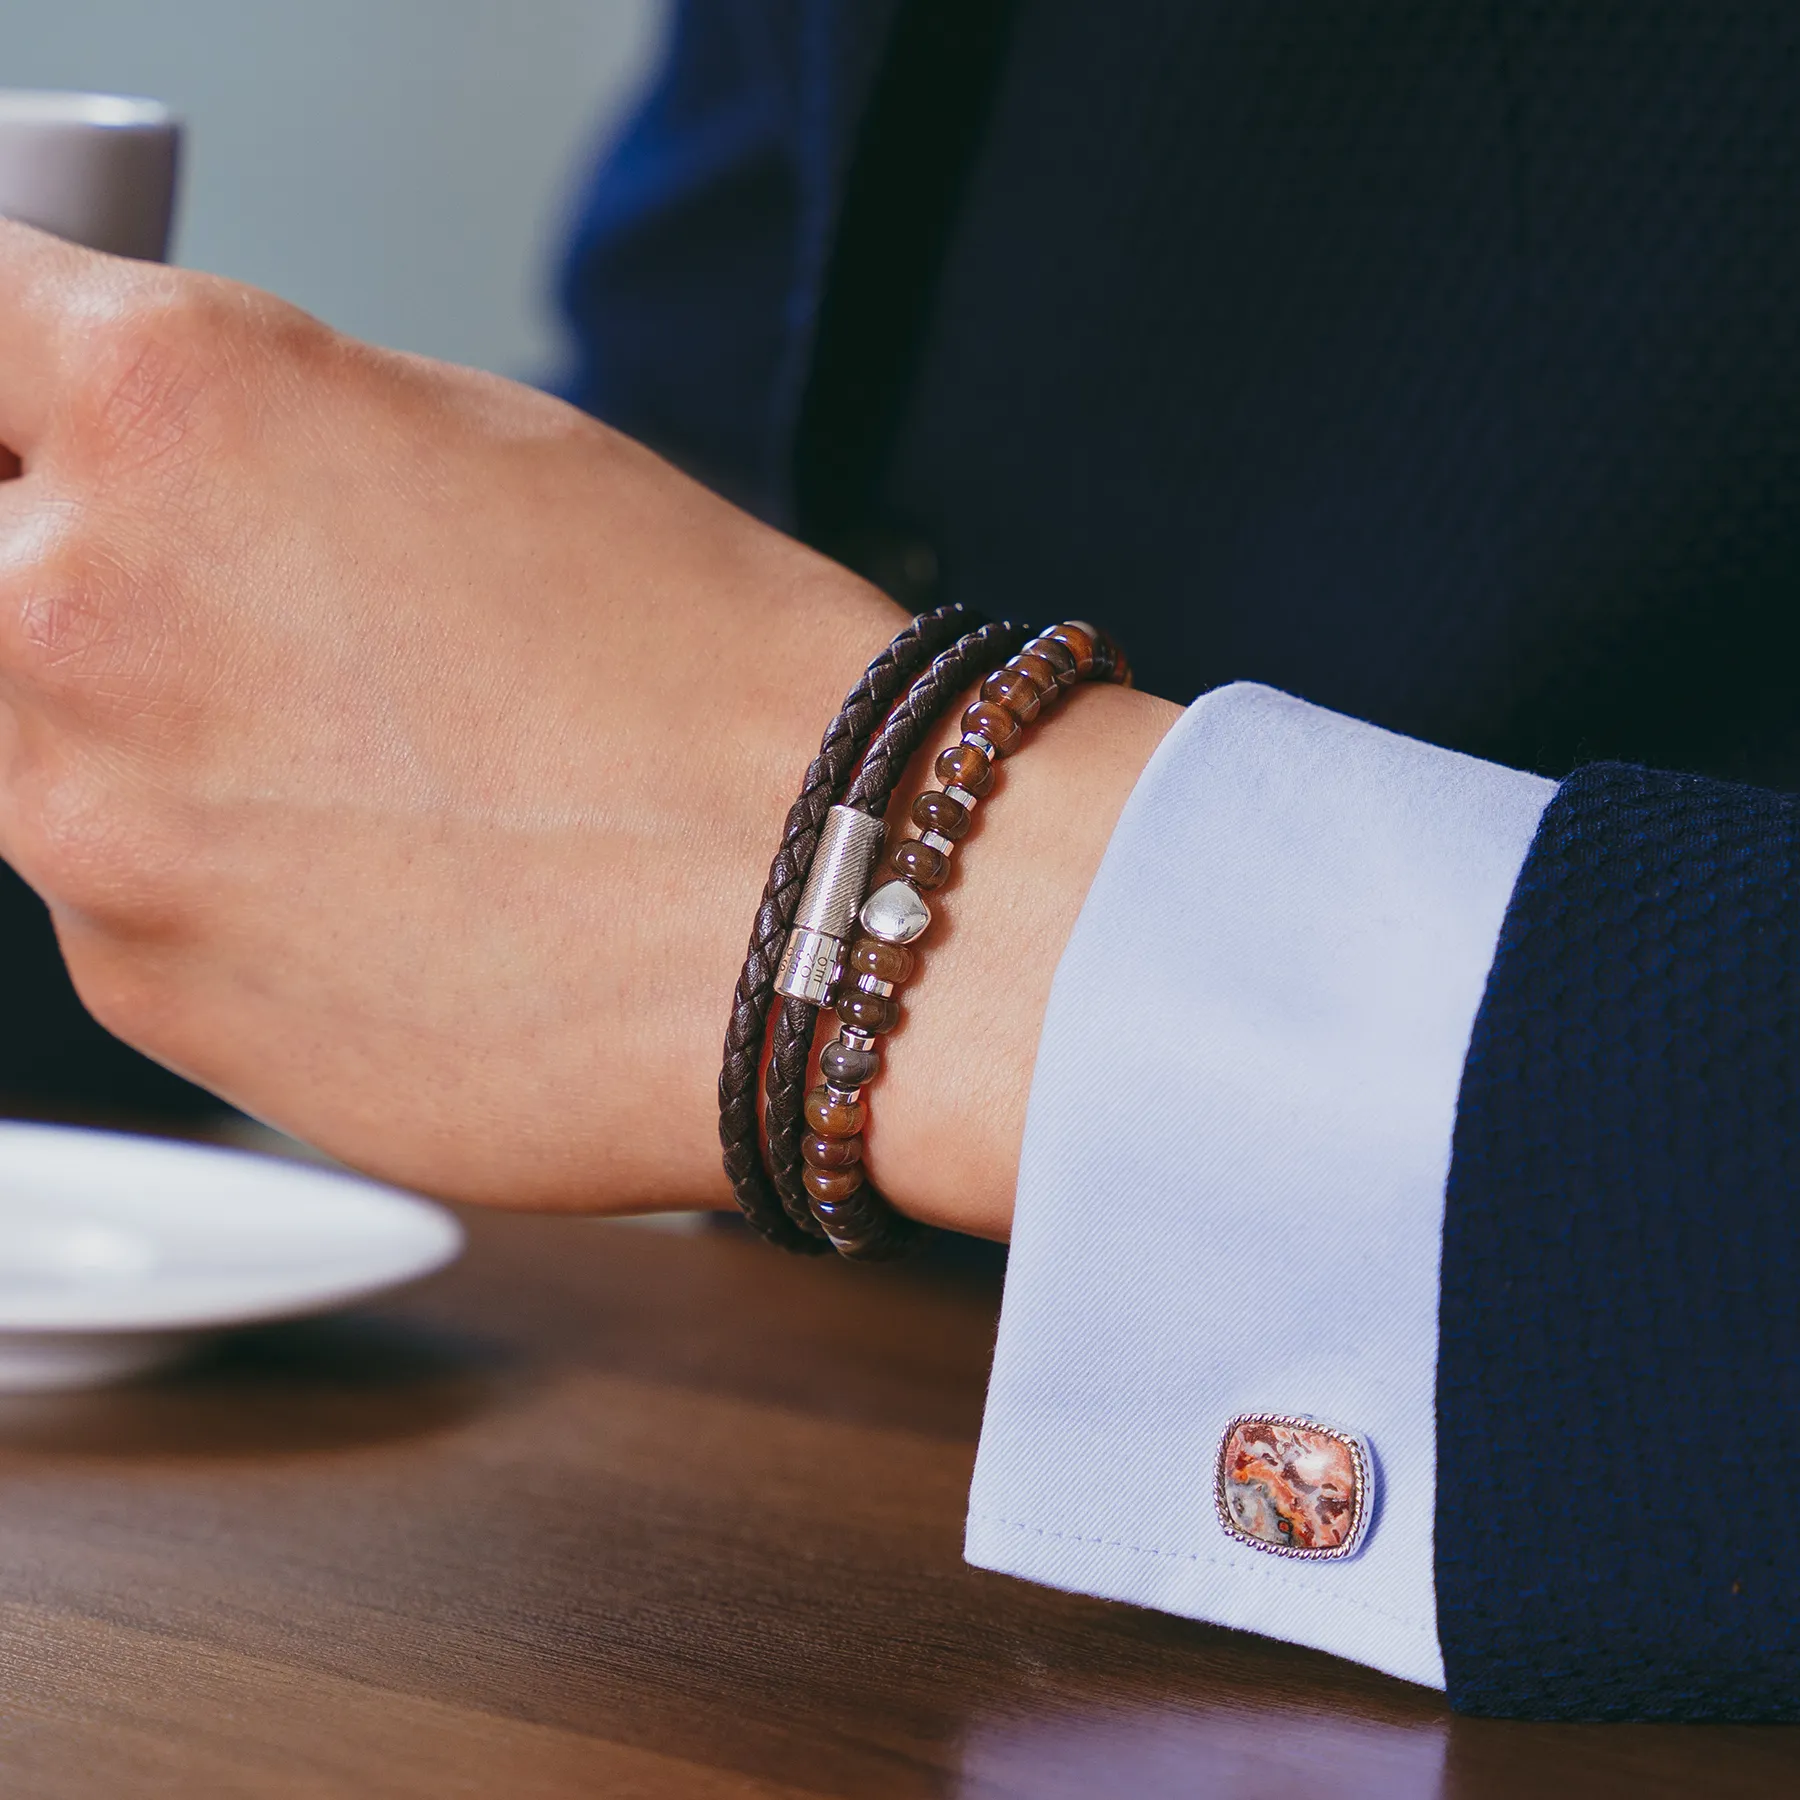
0 223 1175 1237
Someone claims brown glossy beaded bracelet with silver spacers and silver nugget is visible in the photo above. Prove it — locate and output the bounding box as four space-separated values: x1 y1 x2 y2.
799 619 1130 1260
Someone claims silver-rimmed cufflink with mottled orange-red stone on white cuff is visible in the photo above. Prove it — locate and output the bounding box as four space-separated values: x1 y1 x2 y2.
1213 1413 1375 1559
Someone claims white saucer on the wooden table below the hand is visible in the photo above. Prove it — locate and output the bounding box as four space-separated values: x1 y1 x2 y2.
0 1123 463 1393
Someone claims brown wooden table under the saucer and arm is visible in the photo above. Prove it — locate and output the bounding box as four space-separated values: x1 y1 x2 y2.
0 1180 1800 1800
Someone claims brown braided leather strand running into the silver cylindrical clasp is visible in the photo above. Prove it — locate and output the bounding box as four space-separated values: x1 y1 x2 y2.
763 621 1031 1262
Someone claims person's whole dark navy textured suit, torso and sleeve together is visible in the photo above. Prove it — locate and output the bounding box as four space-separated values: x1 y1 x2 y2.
571 0 1800 1715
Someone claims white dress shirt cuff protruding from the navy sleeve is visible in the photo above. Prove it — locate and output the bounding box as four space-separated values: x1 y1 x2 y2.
967 684 1553 1688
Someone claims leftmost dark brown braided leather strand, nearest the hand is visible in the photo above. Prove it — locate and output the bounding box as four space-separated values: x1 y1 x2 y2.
718 607 979 1255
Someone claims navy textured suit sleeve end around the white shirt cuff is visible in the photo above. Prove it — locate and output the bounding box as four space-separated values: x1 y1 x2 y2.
1436 765 1800 1719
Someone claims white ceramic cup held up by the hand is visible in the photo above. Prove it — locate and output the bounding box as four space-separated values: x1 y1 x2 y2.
0 88 182 263
